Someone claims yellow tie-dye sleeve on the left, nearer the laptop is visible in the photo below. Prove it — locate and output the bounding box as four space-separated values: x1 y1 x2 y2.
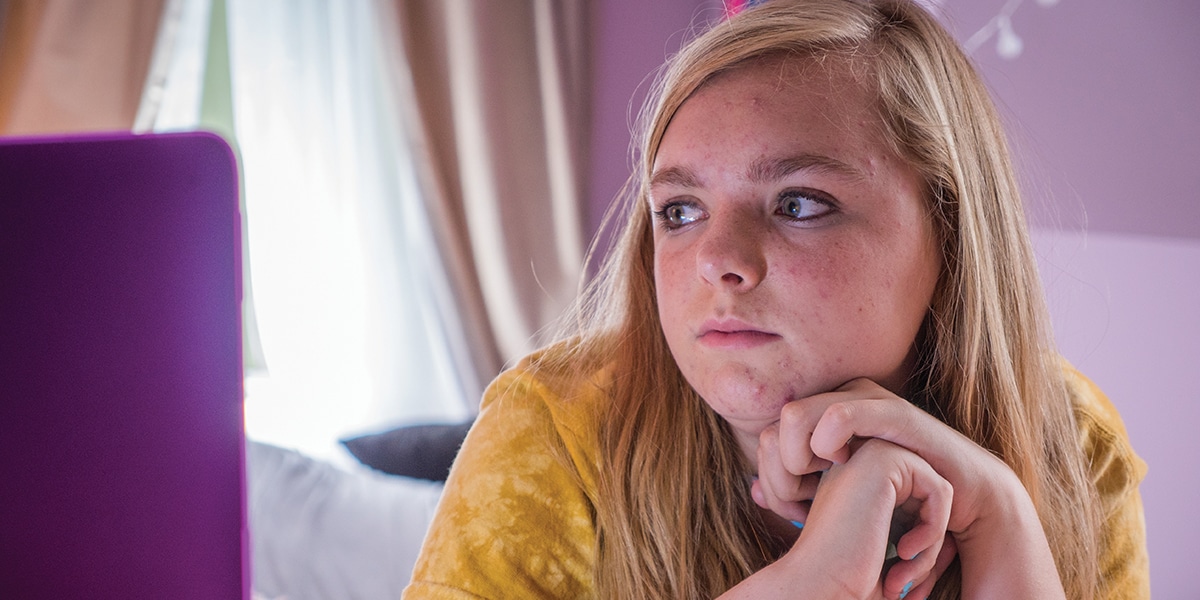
403 371 595 600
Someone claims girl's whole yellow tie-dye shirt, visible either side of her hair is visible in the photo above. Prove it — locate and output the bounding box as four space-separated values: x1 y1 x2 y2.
403 350 1150 600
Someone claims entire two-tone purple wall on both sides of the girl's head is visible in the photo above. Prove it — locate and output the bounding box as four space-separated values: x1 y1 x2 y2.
588 0 1200 590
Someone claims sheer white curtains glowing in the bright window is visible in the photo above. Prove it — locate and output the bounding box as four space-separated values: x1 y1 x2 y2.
139 0 480 458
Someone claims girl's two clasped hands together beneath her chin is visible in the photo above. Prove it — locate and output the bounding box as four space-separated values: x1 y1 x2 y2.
751 379 1061 599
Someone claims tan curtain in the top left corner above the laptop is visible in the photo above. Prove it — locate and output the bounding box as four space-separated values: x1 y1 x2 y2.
0 0 164 136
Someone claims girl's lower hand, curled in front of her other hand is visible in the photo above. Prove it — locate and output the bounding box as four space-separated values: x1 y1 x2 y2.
722 439 955 600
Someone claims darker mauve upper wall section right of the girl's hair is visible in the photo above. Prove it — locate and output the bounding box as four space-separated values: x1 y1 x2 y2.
943 0 1200 239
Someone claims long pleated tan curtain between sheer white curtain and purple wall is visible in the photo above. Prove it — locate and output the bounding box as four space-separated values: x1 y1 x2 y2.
379 0 590 379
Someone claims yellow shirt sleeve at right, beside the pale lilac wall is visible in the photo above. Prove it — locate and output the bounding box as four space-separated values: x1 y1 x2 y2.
1067 370 1150 600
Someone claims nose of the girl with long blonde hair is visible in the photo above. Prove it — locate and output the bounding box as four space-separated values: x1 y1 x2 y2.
696 215 767 292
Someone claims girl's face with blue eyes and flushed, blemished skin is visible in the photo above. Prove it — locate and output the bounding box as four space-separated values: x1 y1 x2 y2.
649 58 941 460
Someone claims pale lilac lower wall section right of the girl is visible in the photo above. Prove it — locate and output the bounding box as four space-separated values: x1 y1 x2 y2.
1034 229 1200 598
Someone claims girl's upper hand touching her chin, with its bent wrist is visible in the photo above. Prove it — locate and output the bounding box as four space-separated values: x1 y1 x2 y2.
752 379 1062 598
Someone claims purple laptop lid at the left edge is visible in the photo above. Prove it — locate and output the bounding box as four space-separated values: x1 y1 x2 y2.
0 133 250 600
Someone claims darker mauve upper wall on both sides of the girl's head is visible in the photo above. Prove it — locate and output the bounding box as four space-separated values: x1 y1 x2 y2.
588 0 1200 239
